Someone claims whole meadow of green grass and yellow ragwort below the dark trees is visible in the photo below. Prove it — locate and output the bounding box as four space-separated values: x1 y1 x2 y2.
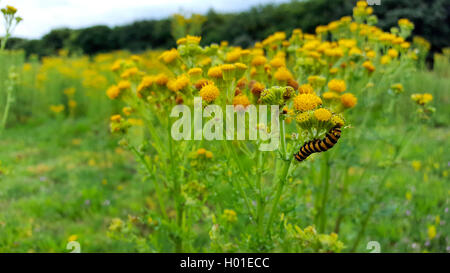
0 1 450 252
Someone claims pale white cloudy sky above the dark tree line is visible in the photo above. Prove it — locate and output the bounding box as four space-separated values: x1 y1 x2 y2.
0 0 289 38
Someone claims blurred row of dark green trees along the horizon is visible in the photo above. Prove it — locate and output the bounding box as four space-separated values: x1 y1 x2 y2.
3 0 450 60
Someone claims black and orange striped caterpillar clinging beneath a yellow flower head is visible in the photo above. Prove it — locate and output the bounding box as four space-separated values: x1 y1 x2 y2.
294 125 341 162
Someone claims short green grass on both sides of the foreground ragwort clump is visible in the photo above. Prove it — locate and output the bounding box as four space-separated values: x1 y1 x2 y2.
0 67 450 252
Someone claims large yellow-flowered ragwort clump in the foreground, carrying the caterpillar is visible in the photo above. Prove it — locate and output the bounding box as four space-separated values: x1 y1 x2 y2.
106 1 432 252
